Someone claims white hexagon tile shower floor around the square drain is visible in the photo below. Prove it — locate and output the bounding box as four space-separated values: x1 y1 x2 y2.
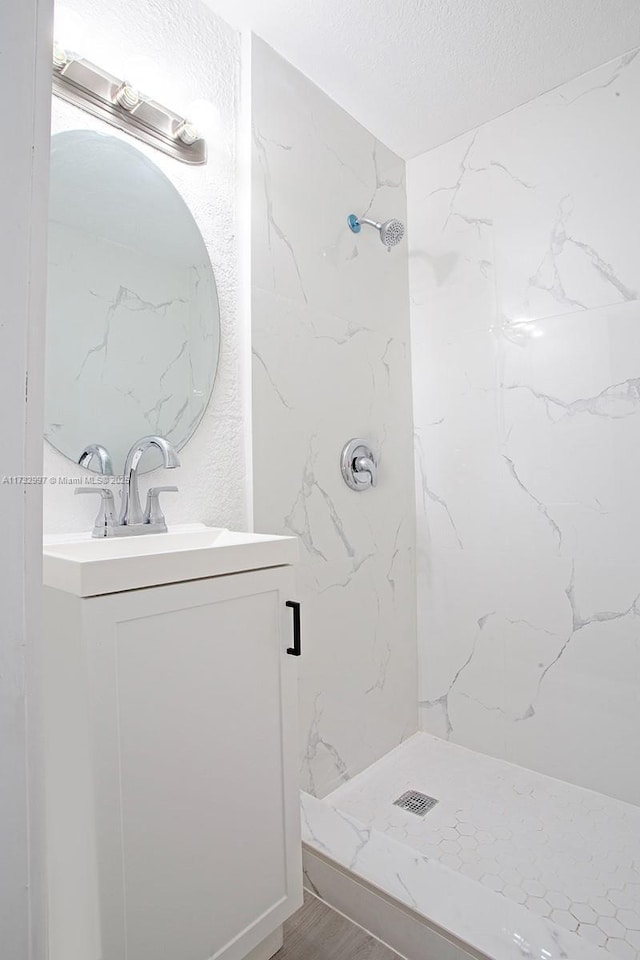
325 734 640 960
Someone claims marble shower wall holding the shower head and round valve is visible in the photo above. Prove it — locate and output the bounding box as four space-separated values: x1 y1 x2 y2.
252 39 417 796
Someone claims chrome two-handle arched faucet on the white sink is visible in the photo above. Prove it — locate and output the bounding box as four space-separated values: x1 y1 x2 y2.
76 436 180 537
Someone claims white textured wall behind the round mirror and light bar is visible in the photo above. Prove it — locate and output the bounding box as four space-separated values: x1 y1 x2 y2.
44 0 250 533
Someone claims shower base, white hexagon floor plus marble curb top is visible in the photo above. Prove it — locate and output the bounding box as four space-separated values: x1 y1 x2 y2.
302 733 640 960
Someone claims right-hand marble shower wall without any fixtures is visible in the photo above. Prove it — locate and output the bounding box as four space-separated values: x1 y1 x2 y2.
408 48 640 802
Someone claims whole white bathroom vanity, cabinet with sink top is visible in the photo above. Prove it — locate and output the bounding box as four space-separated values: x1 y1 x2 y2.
44 525 302 960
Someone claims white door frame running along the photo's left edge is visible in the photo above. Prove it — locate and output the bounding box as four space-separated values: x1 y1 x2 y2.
0 0 52 960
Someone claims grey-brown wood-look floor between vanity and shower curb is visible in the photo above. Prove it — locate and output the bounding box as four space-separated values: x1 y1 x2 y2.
273 893 400 960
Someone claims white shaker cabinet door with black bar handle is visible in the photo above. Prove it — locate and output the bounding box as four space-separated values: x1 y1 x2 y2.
83 567 302 960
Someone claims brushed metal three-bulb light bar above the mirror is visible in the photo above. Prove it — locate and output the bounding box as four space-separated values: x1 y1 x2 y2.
53 42 207 164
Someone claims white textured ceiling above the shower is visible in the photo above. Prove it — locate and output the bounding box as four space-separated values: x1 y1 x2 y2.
201 0 640 158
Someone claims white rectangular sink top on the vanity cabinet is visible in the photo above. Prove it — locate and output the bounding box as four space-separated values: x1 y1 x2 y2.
43 523 298 597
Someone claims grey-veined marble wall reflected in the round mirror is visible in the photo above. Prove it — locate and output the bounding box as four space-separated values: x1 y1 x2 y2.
45 222 219 472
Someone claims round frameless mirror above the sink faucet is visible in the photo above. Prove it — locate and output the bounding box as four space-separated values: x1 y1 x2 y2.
45 130 220 474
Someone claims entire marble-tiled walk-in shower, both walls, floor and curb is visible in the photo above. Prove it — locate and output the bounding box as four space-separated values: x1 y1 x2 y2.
252 30 640 960
